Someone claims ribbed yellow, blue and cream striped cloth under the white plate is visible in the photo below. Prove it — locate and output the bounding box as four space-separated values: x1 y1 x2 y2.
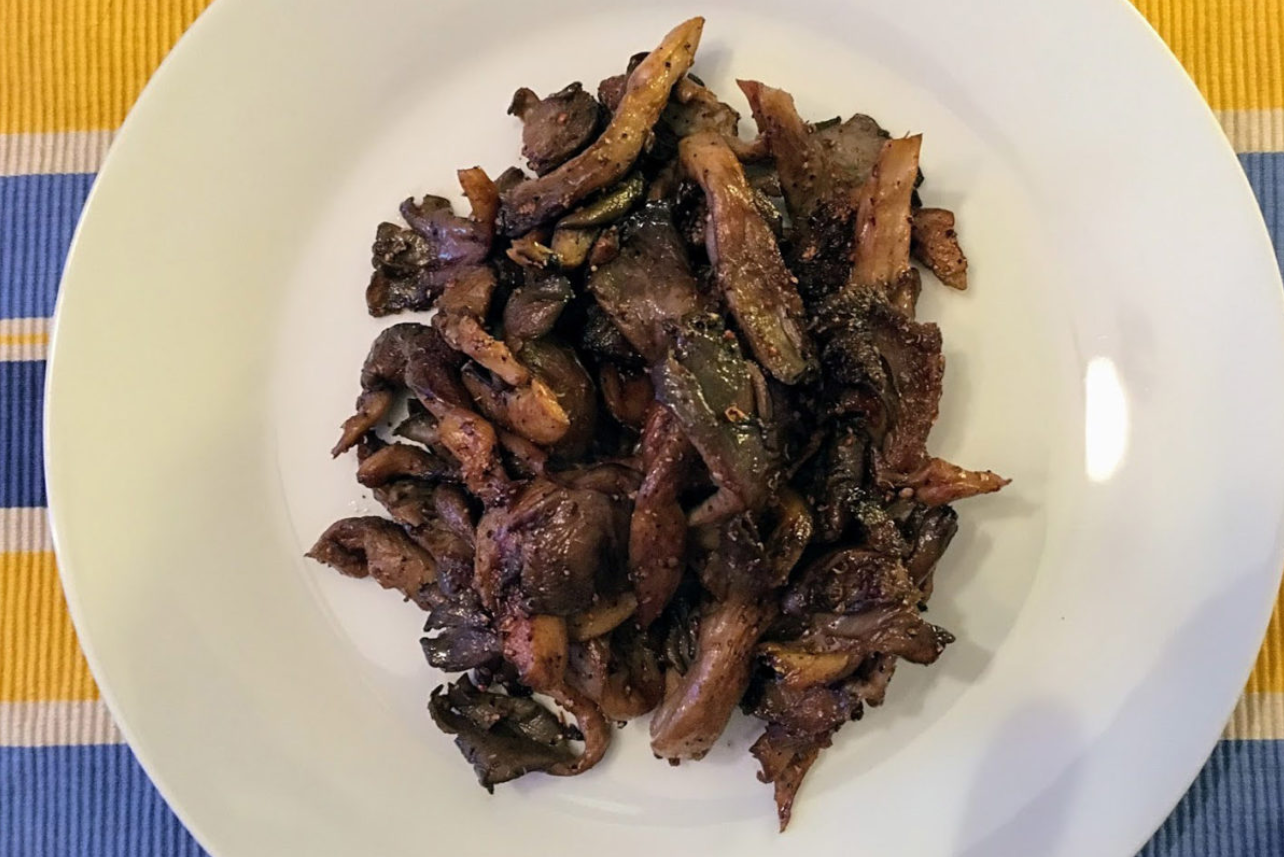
0 0 1284 857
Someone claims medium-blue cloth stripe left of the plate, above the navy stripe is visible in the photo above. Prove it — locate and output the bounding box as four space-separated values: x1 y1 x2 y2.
0 173 94 319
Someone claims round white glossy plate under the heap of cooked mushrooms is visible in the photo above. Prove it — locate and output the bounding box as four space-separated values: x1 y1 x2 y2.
46 0 1284 857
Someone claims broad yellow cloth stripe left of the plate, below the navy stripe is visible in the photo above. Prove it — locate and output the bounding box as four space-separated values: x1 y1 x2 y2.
0 551 98 703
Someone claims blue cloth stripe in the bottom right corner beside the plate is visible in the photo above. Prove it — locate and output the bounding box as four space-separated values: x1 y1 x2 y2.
1140 741 1284 857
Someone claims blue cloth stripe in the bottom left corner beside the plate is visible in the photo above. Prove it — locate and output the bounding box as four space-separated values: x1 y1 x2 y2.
0 744 205 857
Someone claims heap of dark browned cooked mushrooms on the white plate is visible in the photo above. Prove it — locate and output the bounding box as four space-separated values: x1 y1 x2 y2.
308 18 1008 829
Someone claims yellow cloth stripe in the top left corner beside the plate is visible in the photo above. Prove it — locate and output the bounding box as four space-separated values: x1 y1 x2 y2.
0 0 209 134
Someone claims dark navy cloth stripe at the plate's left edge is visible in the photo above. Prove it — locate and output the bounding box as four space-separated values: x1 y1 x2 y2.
0 360 45 508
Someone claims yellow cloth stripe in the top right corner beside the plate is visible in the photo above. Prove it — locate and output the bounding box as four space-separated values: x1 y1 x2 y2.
1132 0 1284 110
